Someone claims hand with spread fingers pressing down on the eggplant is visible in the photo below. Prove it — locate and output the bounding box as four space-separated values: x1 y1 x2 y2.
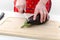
33 2 48 23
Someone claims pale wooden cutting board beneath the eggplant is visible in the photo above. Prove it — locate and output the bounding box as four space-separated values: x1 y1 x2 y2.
0 17 60 40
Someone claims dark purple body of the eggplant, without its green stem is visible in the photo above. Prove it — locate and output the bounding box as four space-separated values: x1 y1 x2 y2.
27 14 48 25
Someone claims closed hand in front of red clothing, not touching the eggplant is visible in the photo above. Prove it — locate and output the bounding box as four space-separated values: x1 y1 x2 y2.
16 0 26 13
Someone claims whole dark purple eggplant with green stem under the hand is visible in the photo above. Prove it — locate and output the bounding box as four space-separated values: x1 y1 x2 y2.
22 14 48 28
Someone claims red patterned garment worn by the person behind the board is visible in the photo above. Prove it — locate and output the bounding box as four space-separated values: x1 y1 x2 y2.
14 0 51 13
